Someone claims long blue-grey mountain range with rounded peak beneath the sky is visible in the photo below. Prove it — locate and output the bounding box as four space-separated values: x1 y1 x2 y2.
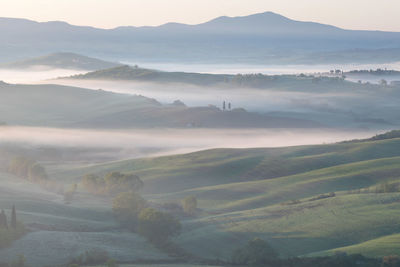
0 12 400 64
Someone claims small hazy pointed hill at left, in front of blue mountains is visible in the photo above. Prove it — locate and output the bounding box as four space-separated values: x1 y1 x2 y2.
0 53 120 71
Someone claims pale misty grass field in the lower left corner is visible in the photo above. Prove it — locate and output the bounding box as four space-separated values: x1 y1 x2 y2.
0 173 169 267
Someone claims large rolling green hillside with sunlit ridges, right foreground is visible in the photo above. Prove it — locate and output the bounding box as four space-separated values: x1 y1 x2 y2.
49 135 400 259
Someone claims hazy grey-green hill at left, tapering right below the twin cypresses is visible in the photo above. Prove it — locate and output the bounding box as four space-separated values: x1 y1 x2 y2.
0 83 320 128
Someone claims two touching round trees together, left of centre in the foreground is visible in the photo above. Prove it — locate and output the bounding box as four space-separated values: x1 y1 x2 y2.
113 192 181 246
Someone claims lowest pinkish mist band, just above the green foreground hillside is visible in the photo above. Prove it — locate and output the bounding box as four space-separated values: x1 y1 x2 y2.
0 126 382 162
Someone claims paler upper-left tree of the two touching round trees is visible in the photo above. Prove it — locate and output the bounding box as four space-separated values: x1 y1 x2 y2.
112 192 146 231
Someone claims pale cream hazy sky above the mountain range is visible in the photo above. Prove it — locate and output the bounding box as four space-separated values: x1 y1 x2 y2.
0 0 400 31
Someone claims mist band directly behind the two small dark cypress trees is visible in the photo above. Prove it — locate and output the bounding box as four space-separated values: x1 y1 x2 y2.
51 79 362 112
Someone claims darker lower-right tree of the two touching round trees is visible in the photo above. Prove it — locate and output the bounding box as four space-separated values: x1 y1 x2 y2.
138 208 181 245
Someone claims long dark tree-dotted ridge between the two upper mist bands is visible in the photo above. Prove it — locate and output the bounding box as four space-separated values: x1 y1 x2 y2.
69 65 379 92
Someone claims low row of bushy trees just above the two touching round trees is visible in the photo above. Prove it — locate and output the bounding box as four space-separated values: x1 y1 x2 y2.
82 172 143 196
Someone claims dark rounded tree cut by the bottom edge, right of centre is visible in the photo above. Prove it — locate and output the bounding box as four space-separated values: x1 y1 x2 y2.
232 238 278 265
